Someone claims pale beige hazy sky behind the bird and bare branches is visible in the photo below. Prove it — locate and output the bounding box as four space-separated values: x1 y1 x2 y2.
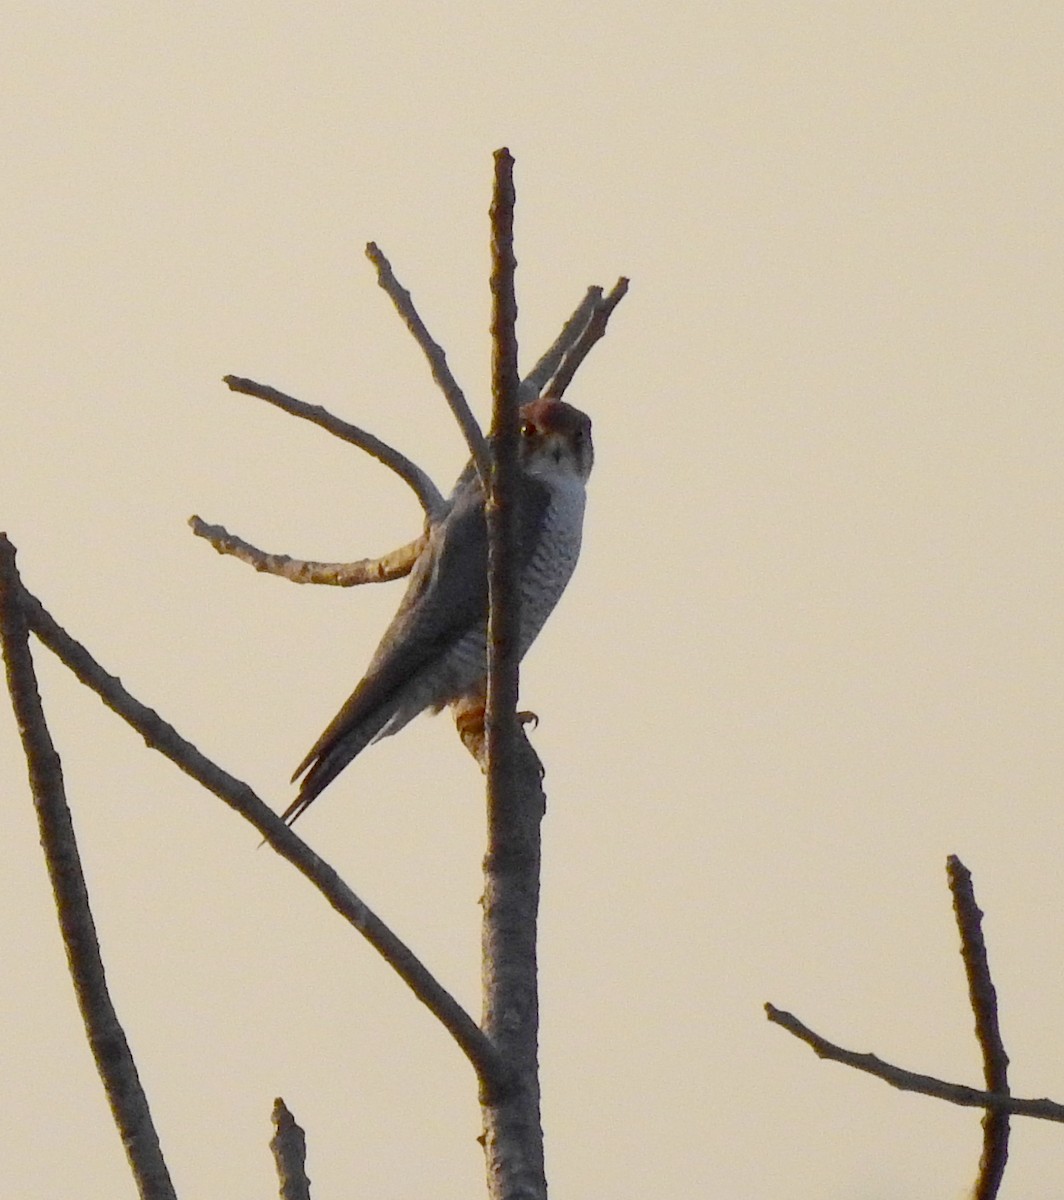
0 0 1064 1200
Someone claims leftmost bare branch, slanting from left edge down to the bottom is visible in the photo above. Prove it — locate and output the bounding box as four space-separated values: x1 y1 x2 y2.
0 534 176 1200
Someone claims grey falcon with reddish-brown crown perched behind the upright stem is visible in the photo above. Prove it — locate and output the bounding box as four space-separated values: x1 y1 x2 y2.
283 398 594 824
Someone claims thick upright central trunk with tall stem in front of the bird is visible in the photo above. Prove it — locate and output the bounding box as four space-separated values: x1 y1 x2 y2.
482 150 547 1200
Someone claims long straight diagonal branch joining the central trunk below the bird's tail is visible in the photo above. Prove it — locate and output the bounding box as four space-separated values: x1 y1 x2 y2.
11 566 509 1088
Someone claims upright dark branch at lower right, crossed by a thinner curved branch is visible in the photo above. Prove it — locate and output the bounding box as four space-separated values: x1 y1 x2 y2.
946 854 1009 1200
